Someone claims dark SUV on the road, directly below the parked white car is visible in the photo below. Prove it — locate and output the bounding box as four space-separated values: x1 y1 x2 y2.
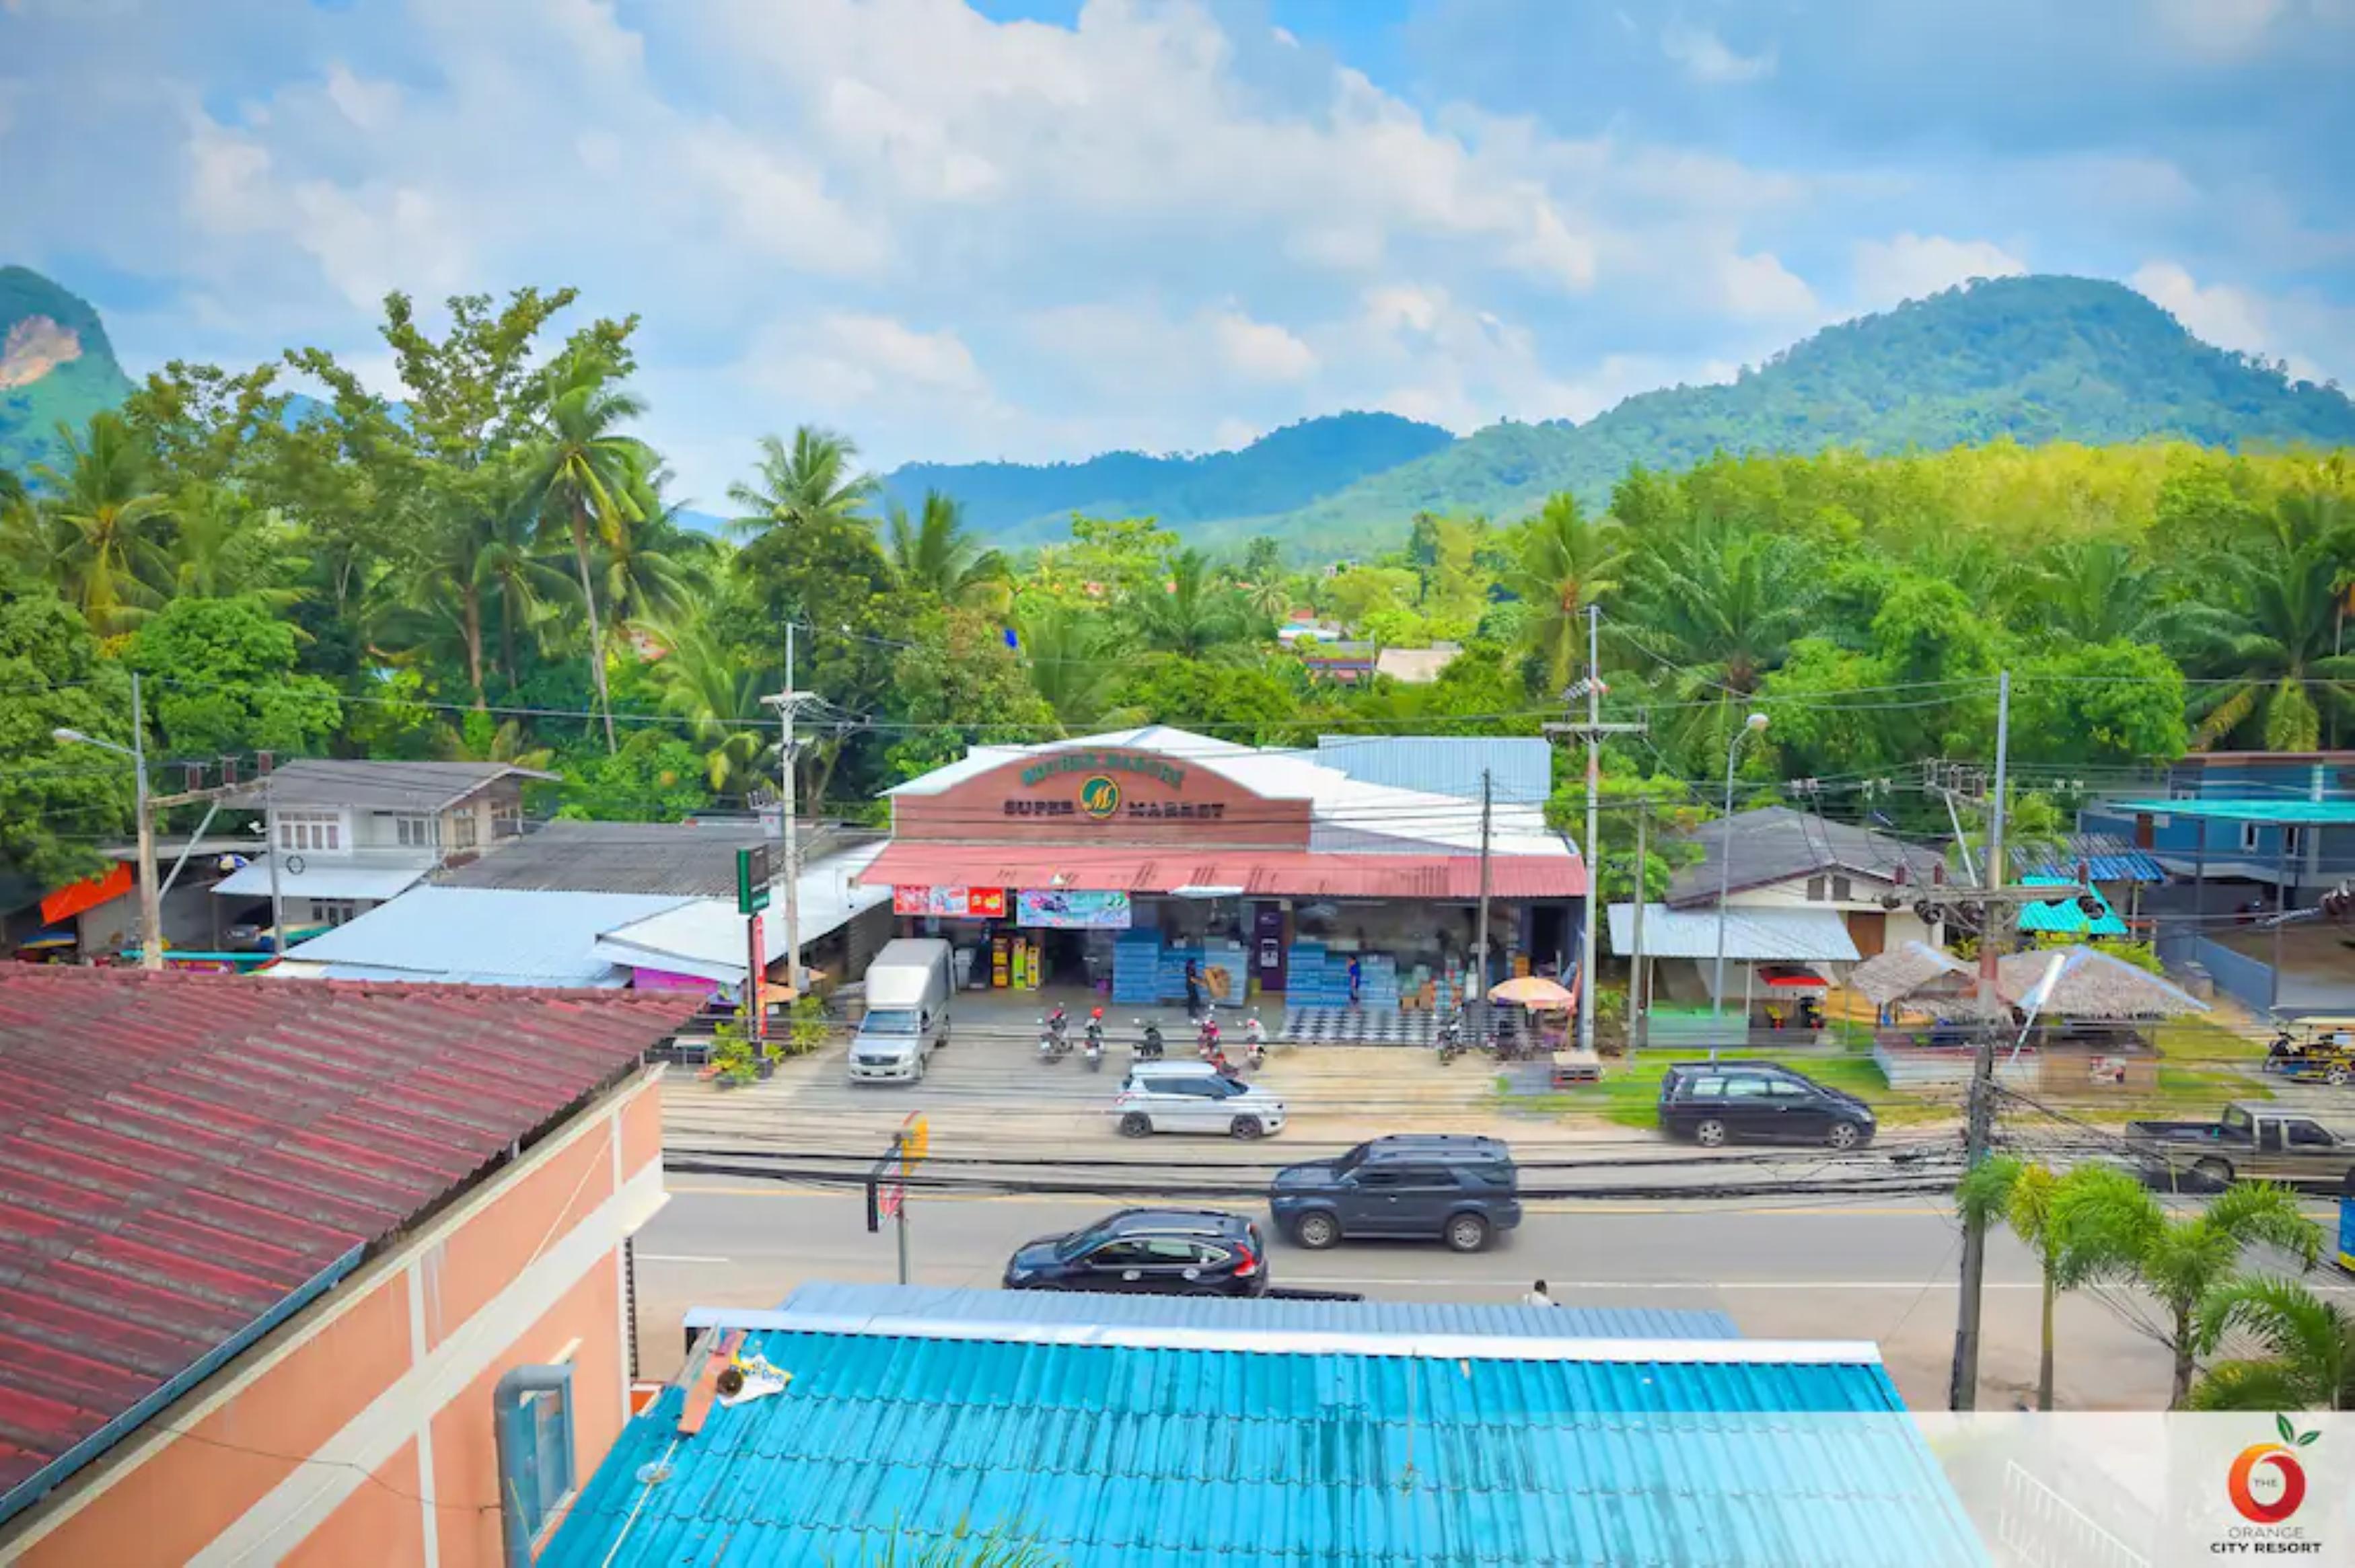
1267 1133 1521 1253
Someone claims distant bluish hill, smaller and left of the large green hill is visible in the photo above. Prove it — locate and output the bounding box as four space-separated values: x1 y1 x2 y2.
883 402 1455 544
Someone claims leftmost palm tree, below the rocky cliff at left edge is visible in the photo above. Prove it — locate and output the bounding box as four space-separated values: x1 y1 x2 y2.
19 412 172 636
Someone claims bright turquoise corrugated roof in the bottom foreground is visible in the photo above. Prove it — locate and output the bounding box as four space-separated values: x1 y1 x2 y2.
540 1326 1988 1568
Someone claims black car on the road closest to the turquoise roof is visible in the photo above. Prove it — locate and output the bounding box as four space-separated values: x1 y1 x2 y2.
1006 1208 1267 1295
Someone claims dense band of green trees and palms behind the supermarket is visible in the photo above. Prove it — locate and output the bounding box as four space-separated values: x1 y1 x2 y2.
0 278 2355 890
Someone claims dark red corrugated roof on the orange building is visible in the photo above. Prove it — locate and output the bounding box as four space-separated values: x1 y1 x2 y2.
0 965 695 1493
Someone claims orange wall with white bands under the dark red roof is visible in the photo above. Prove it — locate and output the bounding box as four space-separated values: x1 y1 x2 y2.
0 1074 662 1568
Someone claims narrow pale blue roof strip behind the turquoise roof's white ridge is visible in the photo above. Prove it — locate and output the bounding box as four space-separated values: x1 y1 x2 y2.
772 1281 1743 1340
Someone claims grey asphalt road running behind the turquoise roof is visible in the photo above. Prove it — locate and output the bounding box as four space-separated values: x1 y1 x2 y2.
639 1175 2350 1411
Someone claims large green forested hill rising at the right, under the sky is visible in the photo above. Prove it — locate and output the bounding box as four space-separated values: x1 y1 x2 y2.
1225 278 2355 554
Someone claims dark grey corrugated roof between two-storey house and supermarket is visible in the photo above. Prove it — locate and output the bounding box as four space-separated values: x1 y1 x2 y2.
433 822 881 899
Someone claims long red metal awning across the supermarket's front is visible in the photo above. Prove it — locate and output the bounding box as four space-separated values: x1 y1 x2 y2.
862 841 1587 899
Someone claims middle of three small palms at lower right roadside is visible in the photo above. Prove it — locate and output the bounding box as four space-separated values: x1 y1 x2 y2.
2063 1182 2322 1411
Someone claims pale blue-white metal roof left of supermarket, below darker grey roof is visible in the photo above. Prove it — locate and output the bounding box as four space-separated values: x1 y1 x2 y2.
287 888 681 987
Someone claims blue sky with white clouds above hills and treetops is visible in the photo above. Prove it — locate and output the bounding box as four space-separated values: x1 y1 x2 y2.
0 0 2355 507
